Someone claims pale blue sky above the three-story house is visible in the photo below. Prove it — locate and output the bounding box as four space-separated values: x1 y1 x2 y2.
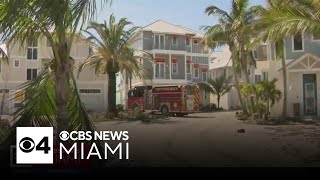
98 0 265 31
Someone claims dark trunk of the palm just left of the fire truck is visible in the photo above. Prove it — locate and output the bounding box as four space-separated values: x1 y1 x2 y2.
108 72 118 116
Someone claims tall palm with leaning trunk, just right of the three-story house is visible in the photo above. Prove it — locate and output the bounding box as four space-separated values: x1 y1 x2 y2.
203 0 264 112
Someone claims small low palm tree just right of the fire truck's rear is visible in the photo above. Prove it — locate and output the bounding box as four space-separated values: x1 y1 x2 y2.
199 75 232 109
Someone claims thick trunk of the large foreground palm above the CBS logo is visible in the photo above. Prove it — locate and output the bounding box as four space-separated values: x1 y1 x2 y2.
55 64 69 136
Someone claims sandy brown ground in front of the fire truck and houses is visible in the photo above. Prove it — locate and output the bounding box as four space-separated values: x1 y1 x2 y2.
96 112 320 167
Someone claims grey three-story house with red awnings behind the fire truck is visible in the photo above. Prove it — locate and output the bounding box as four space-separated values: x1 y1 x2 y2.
119 20 210 105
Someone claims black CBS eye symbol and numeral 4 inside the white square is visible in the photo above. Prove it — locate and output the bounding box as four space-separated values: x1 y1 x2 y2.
19 137 51 154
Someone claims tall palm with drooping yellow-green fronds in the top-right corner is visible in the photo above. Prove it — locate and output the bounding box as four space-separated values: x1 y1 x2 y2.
257 0 320 120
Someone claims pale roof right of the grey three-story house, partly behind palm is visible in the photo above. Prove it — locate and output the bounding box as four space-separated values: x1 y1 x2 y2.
210 46 232 70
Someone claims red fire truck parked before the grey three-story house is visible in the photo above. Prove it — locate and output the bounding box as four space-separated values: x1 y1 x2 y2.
127 84 201 116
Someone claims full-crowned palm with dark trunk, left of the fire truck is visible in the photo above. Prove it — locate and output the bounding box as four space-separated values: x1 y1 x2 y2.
79 15 152 115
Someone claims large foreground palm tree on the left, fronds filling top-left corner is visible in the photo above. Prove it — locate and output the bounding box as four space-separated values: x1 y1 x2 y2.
0 0 108 132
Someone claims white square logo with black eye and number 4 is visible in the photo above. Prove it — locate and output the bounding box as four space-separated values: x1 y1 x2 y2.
17 127 53 164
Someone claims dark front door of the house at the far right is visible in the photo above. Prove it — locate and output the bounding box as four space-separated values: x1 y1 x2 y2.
303 74 317 116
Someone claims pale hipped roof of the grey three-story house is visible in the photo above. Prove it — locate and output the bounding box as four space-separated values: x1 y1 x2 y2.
143 20 203 37
